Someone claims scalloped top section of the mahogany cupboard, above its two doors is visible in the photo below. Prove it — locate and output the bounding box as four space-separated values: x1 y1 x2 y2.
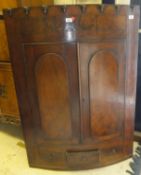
4 5 140 43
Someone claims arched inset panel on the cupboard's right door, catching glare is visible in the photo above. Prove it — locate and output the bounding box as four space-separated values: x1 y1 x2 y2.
89 51 124 138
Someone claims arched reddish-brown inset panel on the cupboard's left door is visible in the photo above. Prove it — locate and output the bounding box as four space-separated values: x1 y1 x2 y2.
35 54 72 139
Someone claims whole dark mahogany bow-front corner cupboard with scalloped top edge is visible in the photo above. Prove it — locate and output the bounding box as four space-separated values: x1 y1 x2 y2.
4 5 139 170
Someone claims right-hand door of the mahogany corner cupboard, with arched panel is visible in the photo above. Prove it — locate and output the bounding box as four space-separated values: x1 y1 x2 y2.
79 41 125 142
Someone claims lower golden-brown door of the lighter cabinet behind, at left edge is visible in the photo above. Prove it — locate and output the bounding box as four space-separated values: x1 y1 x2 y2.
0 63 19 120
